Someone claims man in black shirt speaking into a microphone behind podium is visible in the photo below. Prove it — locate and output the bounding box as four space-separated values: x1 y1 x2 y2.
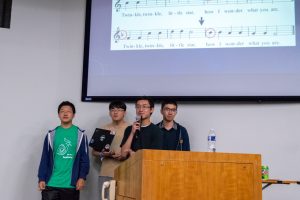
121 97 163 158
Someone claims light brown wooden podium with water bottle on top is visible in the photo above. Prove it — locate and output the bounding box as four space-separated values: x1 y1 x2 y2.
114 150 262 200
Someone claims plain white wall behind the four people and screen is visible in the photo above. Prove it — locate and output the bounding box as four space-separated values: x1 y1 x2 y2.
0 0 300 200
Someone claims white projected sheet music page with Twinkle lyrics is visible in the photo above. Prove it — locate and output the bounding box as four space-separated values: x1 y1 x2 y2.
111 0 296 50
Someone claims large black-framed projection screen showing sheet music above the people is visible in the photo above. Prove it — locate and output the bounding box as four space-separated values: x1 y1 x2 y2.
82 0 300 101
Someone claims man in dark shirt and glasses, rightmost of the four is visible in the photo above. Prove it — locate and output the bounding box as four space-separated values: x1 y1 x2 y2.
157 100 190 151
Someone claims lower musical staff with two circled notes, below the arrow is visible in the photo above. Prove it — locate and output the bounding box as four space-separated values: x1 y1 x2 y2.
114 25 295 43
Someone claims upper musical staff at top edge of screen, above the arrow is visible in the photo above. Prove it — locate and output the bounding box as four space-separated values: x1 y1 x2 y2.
113 0 295 12
